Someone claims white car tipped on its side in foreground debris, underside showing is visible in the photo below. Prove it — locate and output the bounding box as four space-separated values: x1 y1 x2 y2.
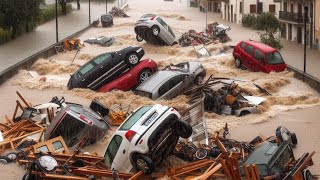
104 104 192 173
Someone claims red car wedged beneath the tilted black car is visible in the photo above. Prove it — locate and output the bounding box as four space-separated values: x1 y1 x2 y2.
98 59 158 92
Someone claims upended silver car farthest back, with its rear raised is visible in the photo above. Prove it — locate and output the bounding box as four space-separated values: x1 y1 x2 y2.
134 14 177 46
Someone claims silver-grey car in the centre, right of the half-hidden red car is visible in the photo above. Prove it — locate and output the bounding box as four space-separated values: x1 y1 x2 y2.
135 62 206 100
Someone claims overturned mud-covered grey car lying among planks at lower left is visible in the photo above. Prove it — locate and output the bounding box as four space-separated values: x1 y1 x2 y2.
44 98 109 147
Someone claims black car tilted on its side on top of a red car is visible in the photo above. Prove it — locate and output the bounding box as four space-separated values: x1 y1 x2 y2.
67 46 144 90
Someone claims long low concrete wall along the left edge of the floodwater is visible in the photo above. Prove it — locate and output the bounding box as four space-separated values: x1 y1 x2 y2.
0 26 90 85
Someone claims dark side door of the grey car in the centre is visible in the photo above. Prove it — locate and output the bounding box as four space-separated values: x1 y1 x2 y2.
158 74 185 99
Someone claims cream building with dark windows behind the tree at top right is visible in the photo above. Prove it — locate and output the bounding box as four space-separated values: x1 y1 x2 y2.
221 0 280 24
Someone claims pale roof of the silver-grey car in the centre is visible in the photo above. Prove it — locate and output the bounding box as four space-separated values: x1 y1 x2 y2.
136 70 185 92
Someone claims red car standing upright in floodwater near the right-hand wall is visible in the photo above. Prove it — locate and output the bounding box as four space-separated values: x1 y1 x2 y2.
233 41 287 73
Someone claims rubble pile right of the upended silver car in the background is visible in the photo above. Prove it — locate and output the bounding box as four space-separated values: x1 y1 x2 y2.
178 23 230 47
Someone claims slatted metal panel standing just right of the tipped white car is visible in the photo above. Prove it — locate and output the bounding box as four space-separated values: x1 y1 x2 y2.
181 91 209 145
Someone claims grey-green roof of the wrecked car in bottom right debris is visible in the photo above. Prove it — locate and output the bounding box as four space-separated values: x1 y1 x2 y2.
245 141 282 165
